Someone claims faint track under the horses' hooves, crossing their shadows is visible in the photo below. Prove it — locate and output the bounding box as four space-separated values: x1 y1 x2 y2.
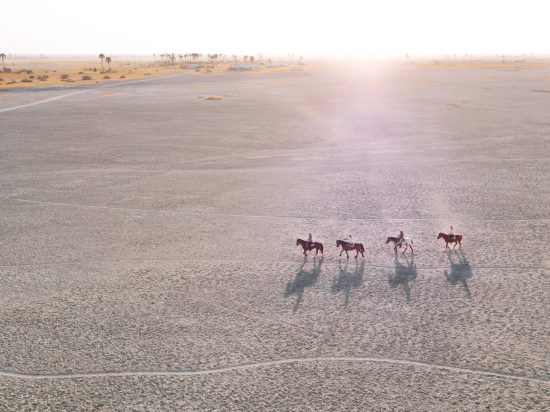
0 255 548 270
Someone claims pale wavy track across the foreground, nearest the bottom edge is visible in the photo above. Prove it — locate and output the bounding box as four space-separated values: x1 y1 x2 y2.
0 356 550 384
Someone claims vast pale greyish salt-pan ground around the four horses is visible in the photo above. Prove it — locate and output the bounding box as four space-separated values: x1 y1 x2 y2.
0 65 550 411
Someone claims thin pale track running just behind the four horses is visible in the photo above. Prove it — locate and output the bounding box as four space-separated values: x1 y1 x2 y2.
10 197 550 222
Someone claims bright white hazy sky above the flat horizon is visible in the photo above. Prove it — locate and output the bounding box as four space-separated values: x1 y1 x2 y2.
4 0 550 57
